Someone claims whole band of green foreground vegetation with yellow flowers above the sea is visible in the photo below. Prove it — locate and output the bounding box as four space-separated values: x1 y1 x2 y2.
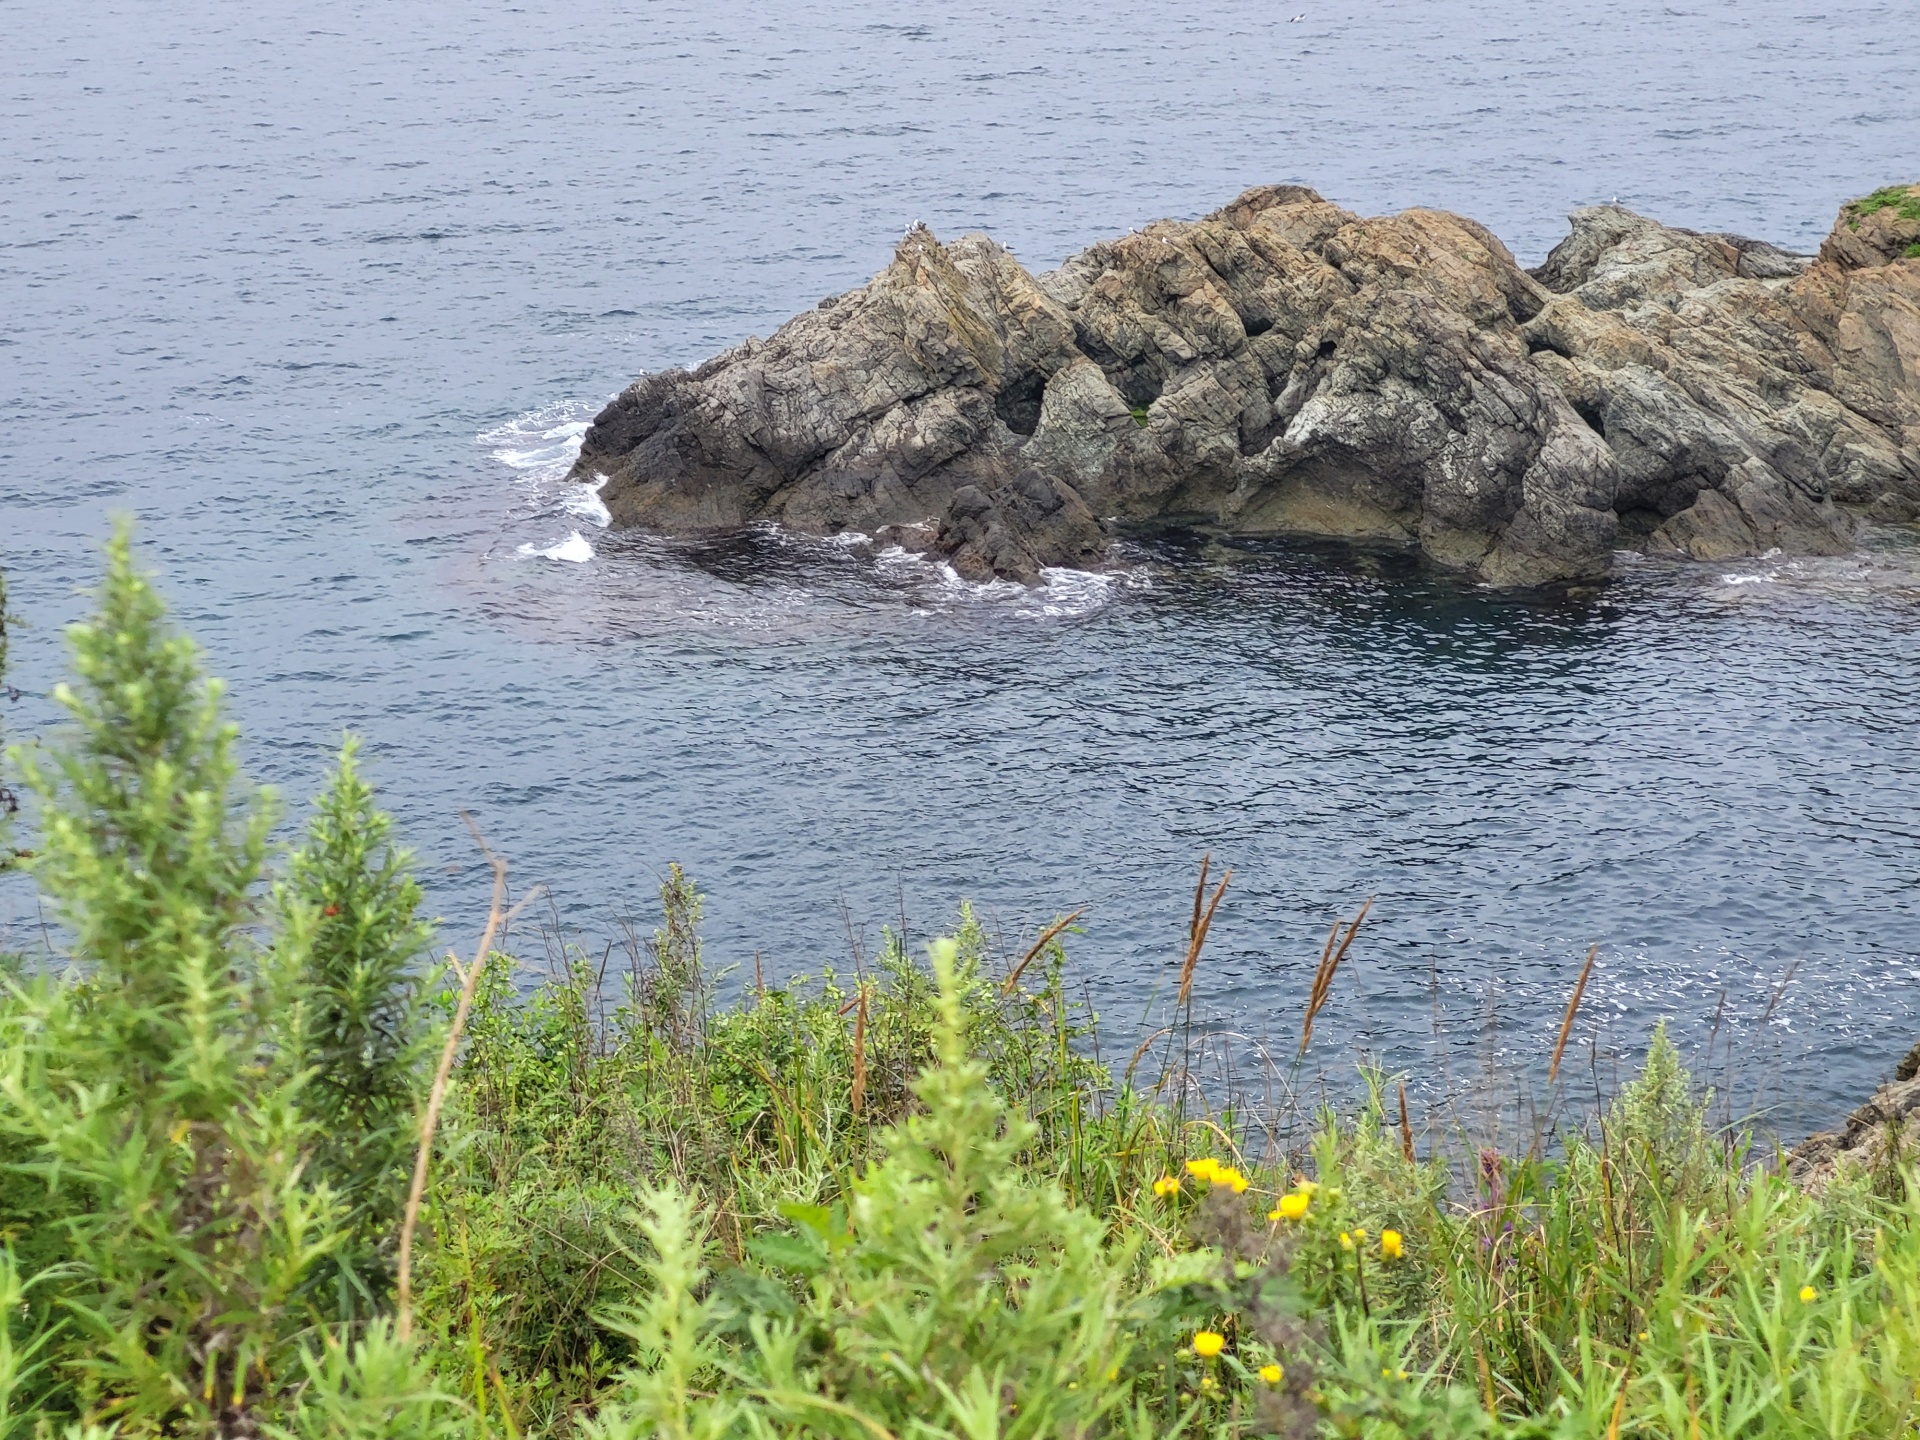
0 536 1920 1440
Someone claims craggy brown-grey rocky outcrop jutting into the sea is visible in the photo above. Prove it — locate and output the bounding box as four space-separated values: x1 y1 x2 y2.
574 186 1920 586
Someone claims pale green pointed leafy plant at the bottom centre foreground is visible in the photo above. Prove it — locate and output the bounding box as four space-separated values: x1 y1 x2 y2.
579 939 1217 1440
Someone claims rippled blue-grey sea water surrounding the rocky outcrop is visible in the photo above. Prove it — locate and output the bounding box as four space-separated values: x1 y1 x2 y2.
0 0 1920 1129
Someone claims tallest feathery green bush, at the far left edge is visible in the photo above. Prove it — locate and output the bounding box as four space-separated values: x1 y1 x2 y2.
0 530 441 1434
